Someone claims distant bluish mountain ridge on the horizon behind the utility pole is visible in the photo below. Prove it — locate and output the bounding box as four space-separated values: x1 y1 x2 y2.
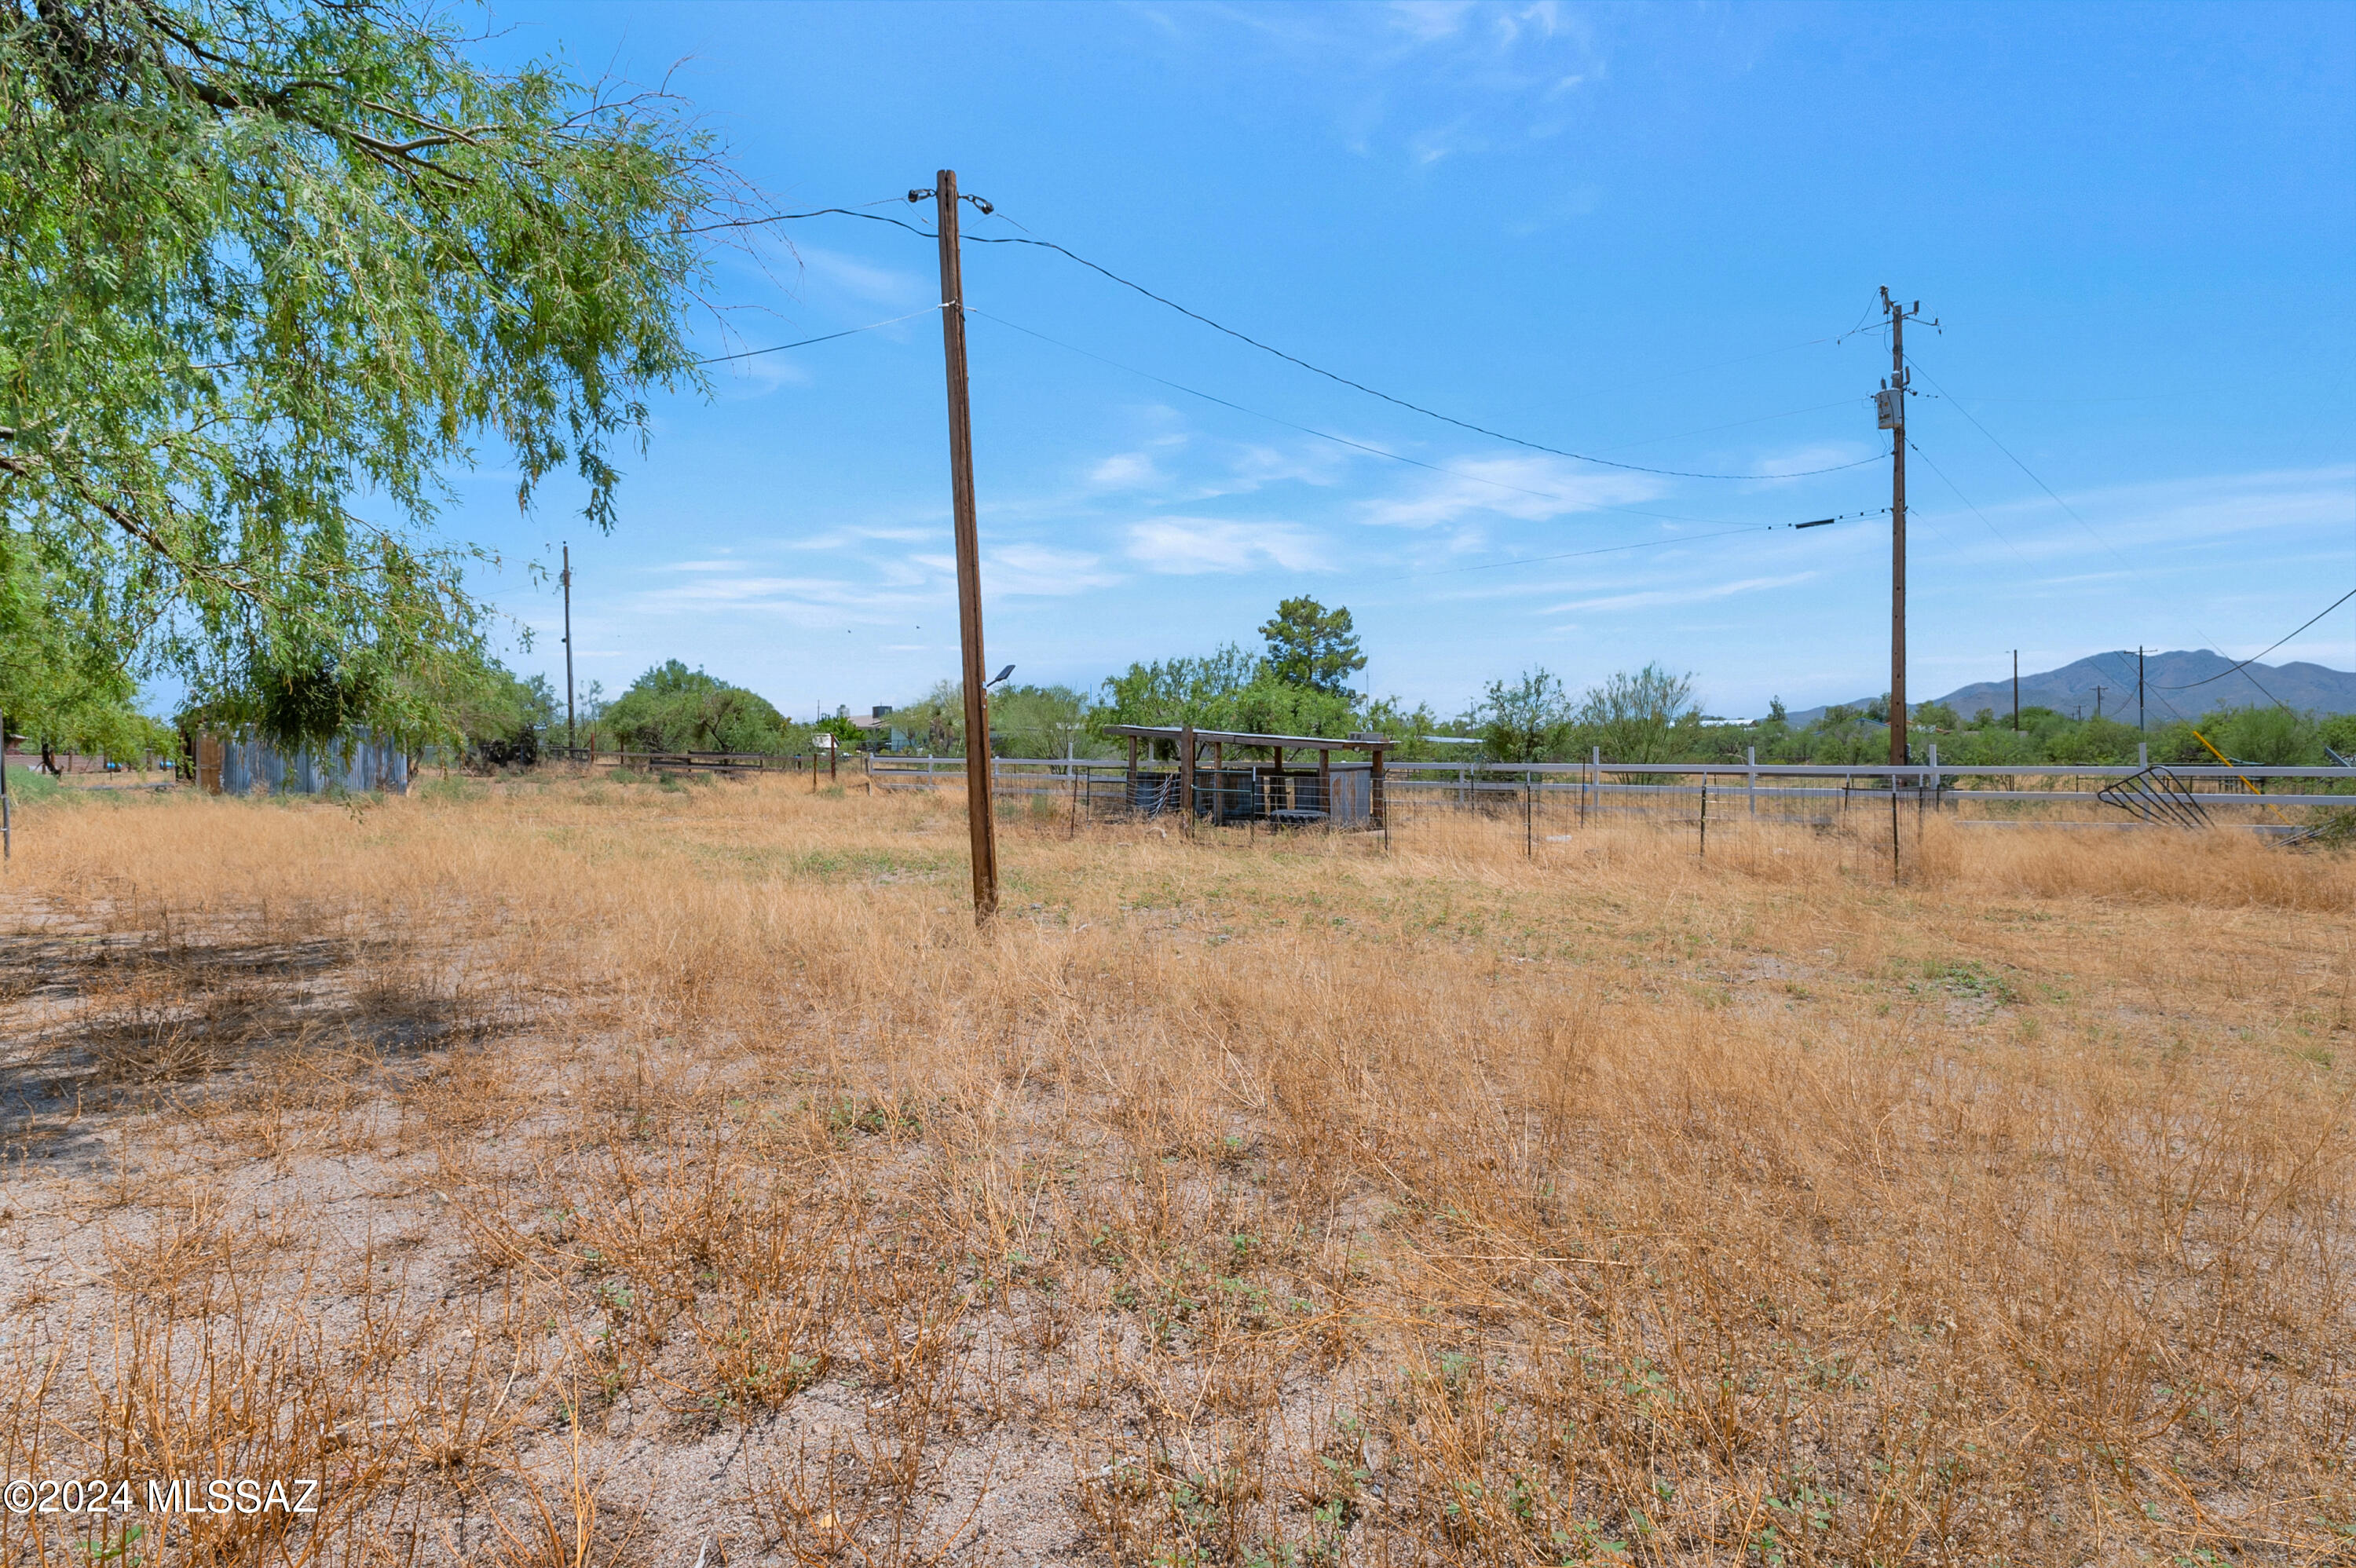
1791 648 2356 728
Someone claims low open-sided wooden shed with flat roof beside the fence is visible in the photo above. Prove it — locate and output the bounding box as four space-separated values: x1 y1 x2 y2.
1105 726 1392 828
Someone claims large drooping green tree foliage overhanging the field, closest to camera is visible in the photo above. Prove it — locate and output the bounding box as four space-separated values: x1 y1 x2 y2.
0 0 733 733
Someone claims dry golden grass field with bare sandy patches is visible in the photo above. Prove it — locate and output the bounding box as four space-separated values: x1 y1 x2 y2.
0 780 2356 1568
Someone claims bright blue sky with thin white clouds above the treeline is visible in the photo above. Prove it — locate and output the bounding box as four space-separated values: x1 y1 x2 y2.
443 5 2356 716
